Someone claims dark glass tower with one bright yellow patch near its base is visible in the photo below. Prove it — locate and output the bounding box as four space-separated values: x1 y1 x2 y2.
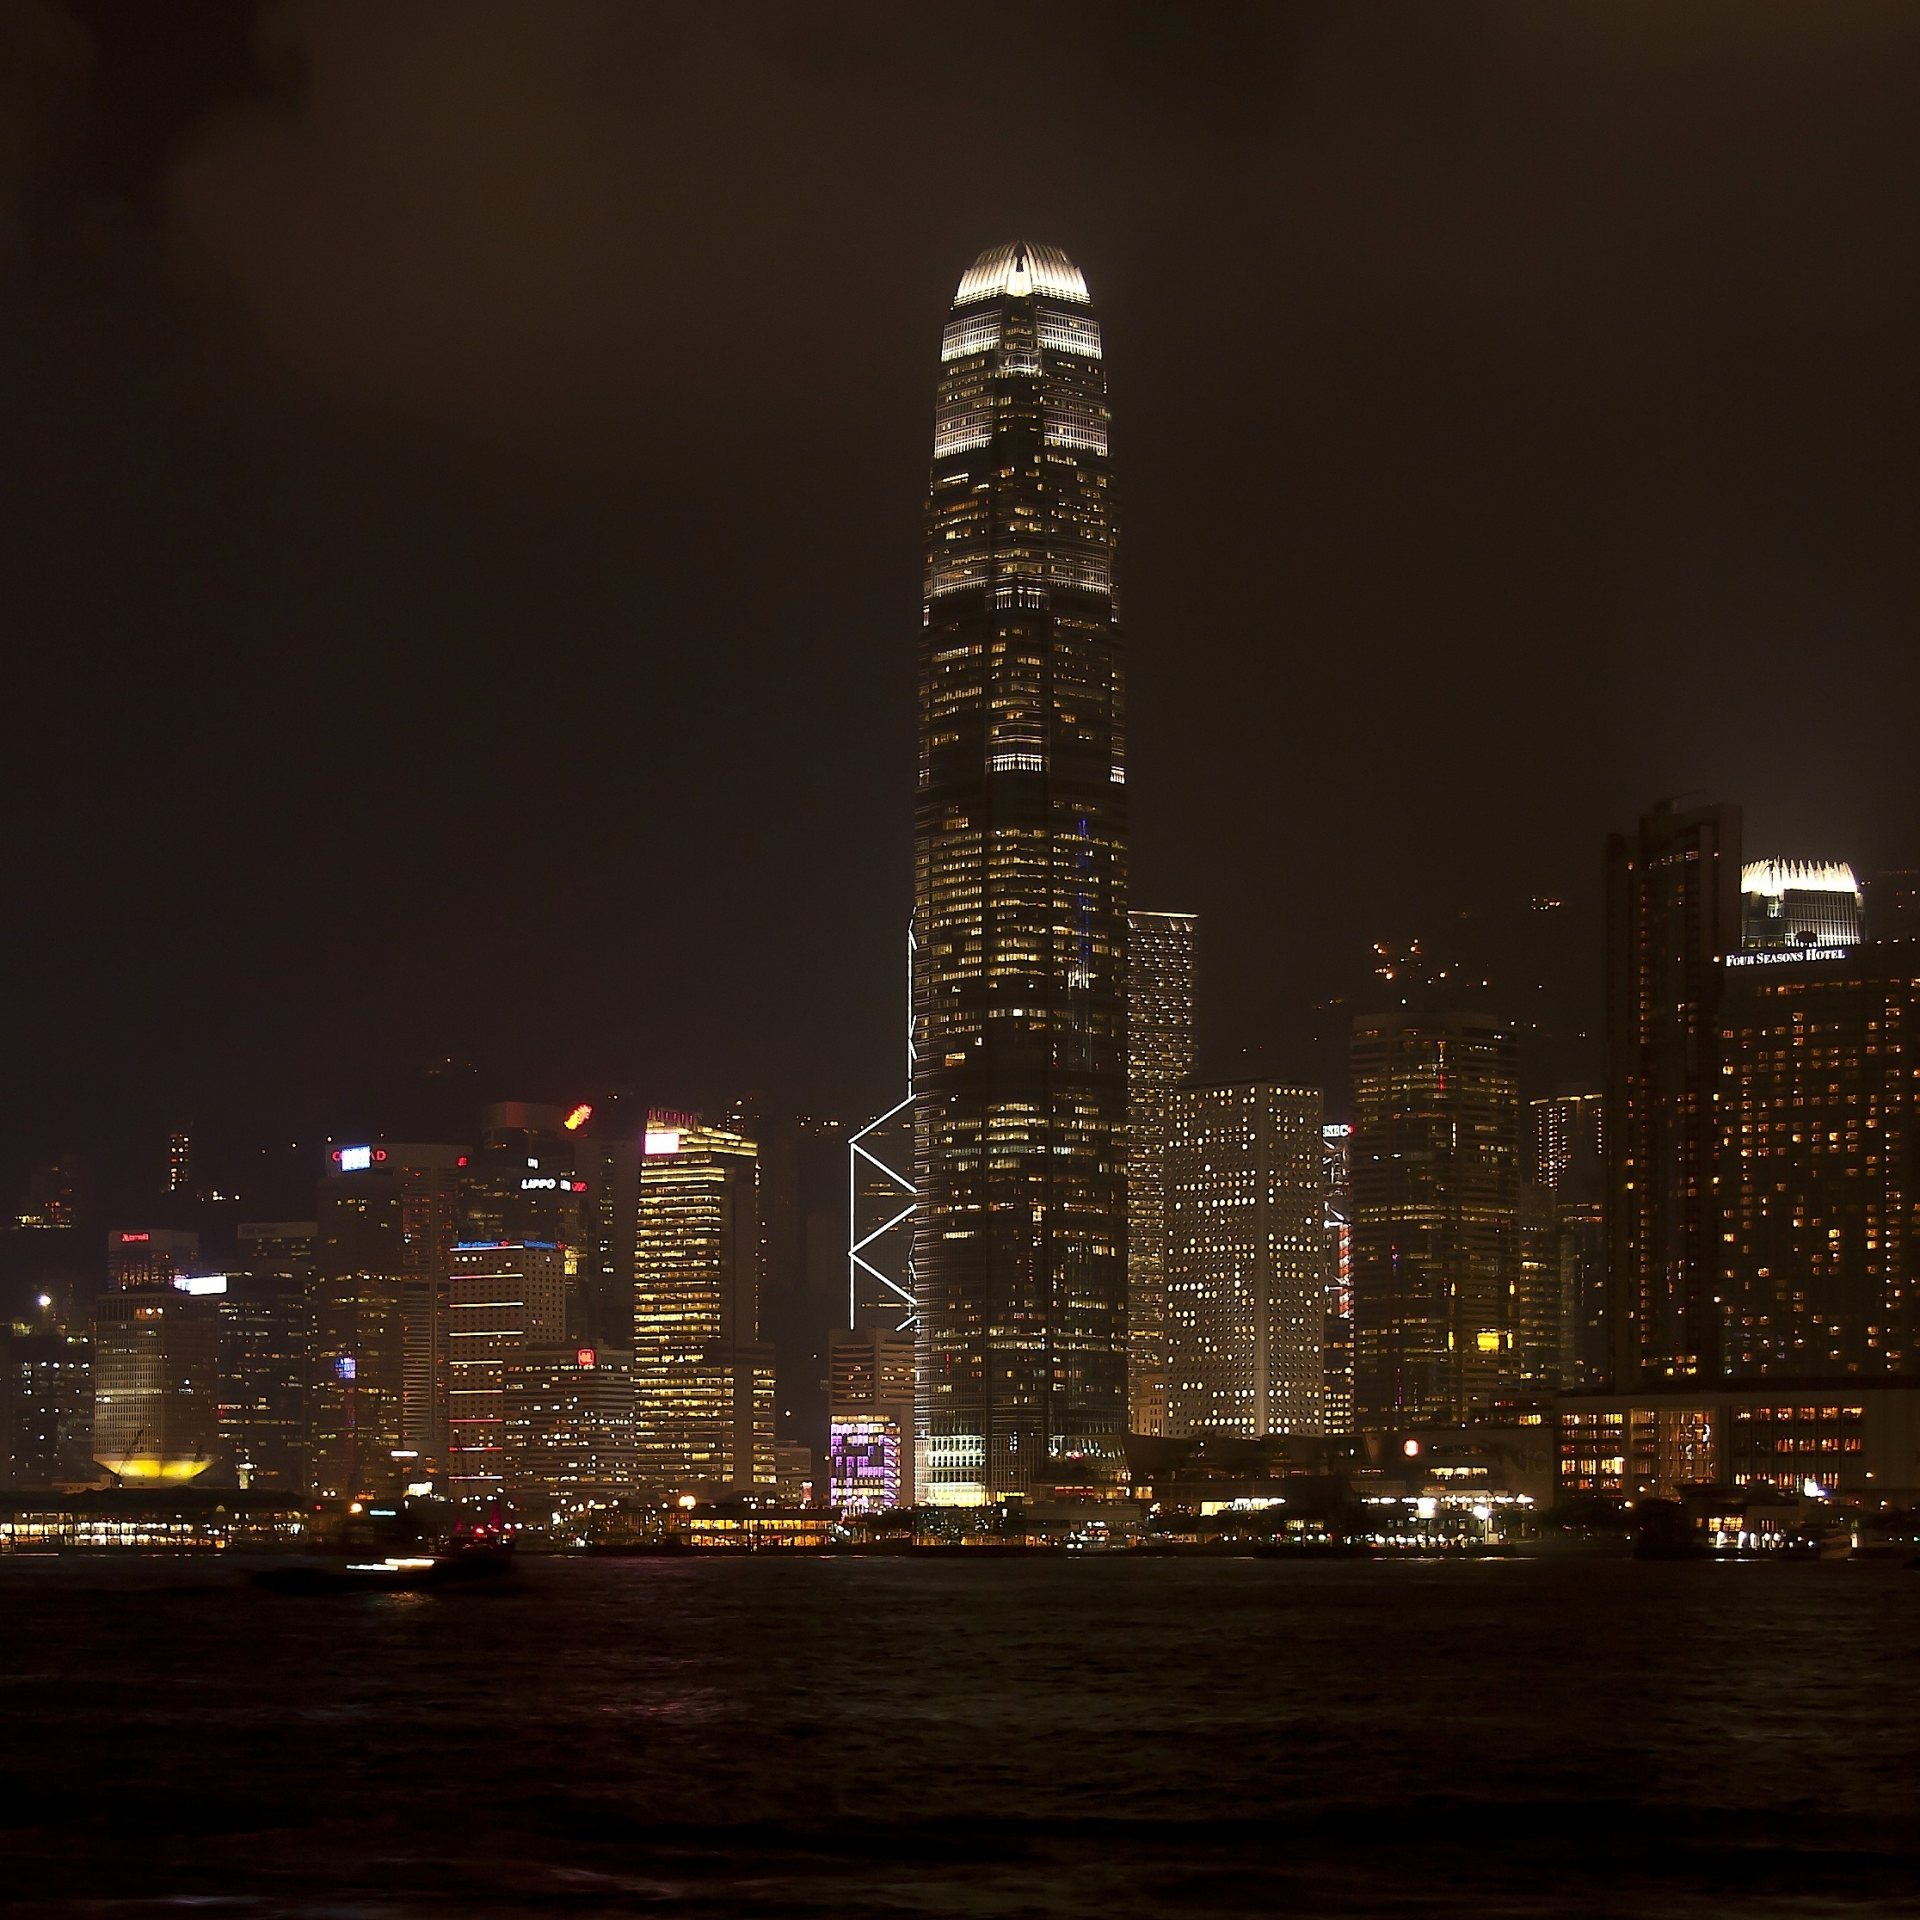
1352 1010 1521 1432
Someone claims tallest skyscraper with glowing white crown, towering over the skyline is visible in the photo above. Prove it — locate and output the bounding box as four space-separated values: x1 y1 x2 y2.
914 242 1127 1505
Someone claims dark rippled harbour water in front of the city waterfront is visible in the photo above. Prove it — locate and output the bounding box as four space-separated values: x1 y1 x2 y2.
0 1557 1920 1920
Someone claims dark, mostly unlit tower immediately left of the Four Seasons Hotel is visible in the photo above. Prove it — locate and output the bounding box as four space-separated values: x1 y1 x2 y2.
1607 801 1740 1386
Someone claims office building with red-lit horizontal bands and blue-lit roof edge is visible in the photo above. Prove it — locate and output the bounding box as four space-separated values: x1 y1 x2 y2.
447 1240 576 1505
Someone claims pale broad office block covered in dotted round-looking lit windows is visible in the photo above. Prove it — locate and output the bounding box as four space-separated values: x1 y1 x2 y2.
1165 1081 1327 1438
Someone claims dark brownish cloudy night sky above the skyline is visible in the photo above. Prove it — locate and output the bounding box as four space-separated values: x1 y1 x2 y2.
0 0 1920 1181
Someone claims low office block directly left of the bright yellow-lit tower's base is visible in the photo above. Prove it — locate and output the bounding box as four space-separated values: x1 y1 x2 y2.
501 1344 634 1526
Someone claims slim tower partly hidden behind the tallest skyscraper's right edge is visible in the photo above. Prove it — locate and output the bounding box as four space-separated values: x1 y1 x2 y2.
1127 912 1194 1434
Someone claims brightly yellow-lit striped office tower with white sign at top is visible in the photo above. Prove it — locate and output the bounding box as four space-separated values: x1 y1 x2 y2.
634 1116 776 1496
